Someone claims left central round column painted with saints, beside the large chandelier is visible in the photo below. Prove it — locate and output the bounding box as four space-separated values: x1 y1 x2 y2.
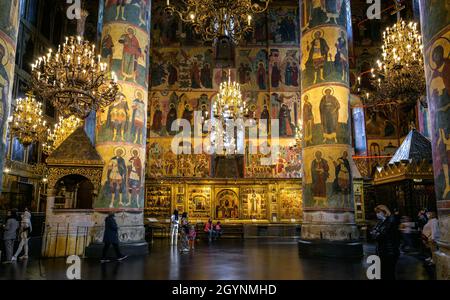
94 0 151 253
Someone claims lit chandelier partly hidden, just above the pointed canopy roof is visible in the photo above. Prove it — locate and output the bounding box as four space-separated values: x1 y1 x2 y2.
42 116 83 155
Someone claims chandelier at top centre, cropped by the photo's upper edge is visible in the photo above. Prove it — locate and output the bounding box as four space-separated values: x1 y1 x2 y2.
166 0 270 44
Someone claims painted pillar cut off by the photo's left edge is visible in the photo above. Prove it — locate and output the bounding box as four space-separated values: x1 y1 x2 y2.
0 0 20 192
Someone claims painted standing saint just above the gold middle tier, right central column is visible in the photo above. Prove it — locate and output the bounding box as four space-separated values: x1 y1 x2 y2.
306 30 330 83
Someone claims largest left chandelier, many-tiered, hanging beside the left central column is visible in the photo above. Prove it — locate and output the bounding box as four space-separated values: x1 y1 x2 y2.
32 36 119 119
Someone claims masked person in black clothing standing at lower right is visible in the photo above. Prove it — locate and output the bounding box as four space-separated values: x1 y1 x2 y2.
371 205 400 280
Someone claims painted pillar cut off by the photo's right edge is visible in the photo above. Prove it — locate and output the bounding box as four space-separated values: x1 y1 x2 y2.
420 0 450 279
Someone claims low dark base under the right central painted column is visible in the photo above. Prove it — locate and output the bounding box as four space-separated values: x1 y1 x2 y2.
298 239 364 258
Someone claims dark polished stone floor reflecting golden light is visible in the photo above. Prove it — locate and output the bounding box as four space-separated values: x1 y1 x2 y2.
0 239 430 280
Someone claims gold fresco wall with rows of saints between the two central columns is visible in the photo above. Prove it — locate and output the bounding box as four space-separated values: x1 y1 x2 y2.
146 0 301 178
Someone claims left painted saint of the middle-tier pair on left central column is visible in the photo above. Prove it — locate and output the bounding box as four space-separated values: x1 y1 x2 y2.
106 92 129 141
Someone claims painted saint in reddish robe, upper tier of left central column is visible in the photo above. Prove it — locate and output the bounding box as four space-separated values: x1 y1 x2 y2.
119 27 143 82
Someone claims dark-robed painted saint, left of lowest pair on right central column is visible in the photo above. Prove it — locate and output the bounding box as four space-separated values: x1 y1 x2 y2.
311 151 330 206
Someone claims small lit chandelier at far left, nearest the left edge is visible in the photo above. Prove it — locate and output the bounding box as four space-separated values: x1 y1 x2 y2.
9 93 47 147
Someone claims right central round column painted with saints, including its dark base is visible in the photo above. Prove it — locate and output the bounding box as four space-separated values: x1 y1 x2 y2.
299 0 362 257
